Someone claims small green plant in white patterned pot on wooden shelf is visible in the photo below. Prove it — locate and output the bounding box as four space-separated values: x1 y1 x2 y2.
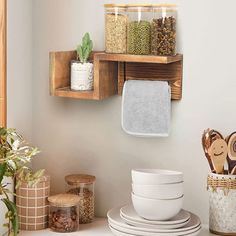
71 33 93 90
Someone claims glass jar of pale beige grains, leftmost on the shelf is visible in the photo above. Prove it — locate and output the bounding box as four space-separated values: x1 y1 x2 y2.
104 4 127 53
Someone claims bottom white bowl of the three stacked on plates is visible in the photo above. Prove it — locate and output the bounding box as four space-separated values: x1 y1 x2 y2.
132 193 183 220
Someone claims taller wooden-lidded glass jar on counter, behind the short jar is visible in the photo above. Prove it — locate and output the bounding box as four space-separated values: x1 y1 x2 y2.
65 174 96 224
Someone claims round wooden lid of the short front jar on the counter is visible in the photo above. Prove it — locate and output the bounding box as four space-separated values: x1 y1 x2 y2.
48 193 80 207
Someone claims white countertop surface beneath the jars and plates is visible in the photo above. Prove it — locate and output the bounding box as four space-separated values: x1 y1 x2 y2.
19 218 214 236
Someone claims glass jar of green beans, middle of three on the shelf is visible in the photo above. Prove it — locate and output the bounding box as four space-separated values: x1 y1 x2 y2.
127 4 152 55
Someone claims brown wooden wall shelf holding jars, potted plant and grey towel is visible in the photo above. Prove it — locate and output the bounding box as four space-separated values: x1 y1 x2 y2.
50 51 183 100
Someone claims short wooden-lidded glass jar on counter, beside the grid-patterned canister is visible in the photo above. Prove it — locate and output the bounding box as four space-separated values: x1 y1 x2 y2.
48 194 80 233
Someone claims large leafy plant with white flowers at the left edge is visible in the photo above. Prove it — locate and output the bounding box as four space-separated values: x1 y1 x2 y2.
0 128 44 236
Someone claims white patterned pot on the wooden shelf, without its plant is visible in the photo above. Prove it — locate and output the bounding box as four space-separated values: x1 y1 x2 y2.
71 61 93 91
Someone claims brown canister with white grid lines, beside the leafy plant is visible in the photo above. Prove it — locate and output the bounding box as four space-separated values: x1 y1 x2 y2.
16 176 50 231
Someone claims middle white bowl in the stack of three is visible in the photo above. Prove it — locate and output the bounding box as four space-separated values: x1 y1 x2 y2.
132 182 184 199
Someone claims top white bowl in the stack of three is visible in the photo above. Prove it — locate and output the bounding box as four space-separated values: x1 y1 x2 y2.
132 169 183 185
